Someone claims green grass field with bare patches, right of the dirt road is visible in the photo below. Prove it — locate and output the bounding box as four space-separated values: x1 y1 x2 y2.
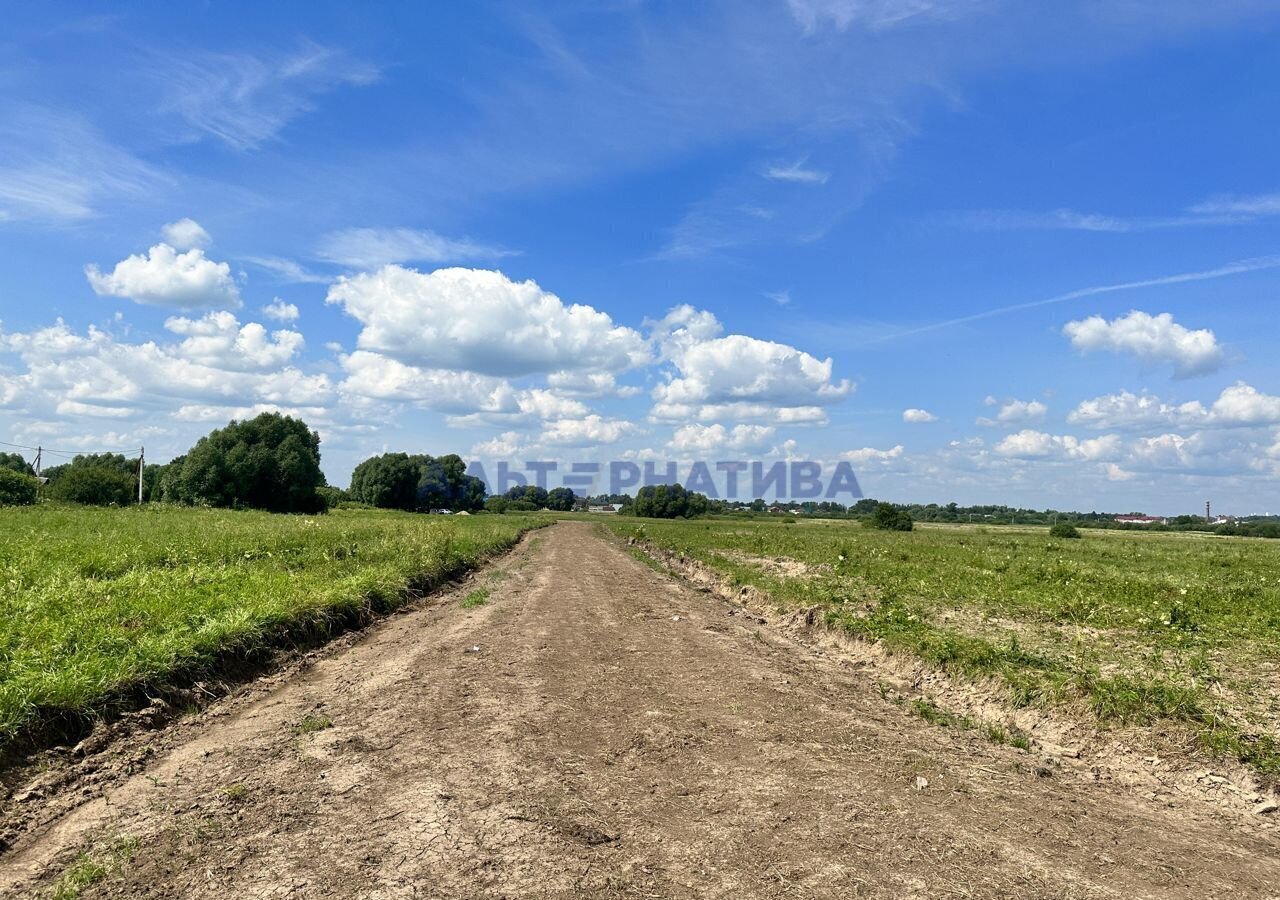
609 518 1280 780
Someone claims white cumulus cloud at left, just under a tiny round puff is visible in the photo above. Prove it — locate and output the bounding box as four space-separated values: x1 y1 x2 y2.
84 243 241 310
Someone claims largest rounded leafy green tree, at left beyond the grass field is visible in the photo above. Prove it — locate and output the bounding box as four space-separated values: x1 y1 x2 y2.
177 412 325 512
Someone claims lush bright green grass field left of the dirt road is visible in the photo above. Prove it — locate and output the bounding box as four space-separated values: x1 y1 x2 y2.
0 506 540 748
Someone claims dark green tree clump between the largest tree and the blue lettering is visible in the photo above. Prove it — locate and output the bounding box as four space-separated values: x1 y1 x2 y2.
348 453 485 512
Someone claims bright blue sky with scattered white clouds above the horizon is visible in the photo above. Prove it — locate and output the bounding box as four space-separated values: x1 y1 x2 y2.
0 0 1280 513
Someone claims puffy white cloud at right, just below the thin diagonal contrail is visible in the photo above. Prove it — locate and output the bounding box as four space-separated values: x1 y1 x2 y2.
1062 310 1222 378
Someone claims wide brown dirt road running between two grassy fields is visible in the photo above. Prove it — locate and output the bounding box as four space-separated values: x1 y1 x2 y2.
0 524 1280 900
